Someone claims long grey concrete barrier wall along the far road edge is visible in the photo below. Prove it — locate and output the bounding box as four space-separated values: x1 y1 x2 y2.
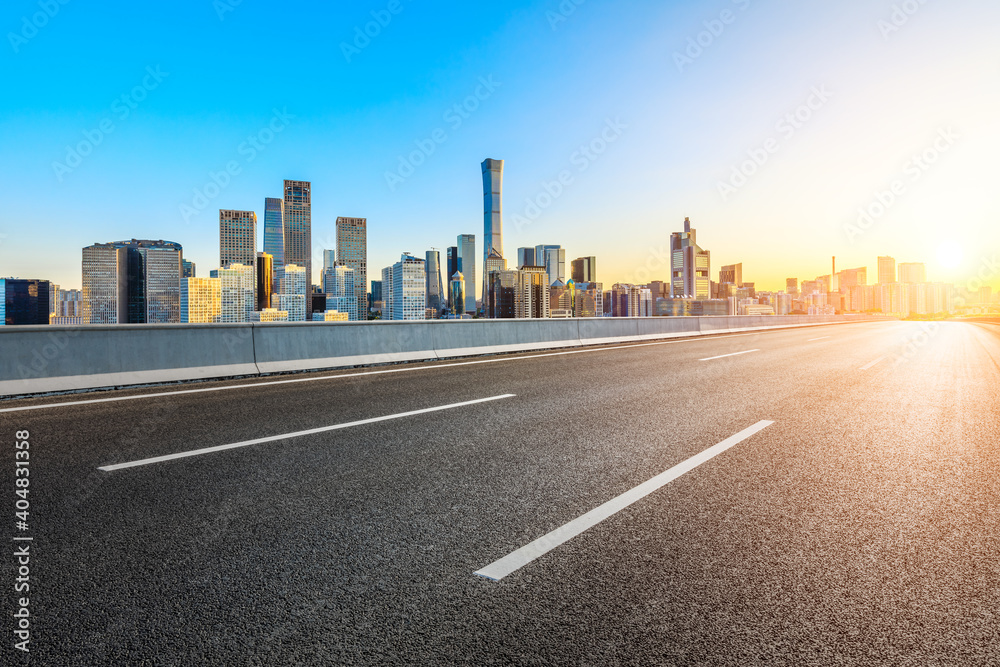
0 315 873 396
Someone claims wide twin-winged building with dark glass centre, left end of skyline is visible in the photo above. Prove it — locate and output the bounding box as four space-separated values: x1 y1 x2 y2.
82 239 183 324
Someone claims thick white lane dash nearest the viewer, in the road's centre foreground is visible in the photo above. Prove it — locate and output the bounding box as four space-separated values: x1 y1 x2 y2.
473 420 774 581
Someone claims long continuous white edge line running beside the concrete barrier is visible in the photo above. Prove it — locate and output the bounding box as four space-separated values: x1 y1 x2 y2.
0 322 836 413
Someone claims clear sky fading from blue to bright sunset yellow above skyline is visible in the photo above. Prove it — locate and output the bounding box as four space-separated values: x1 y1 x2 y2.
0 0 1000 298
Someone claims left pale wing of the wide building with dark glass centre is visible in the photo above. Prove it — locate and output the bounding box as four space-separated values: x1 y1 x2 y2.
81 243 128 324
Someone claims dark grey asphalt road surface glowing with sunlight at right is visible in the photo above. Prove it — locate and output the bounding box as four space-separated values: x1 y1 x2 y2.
0 322 1000 665
